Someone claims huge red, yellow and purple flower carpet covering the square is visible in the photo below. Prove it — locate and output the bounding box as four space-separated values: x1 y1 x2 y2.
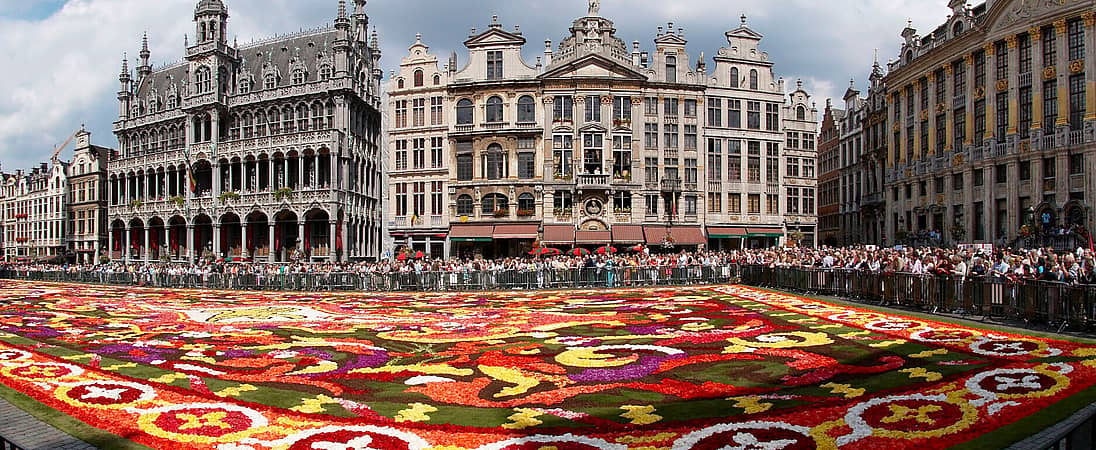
0 281 1096 450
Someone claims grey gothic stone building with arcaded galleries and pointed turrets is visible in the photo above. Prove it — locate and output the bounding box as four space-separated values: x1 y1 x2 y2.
109 0 383 266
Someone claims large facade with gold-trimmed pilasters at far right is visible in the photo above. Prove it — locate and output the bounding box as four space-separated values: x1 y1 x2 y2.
883 0 1096 244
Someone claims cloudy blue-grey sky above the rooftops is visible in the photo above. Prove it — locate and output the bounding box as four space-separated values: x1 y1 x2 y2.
0 0 950 172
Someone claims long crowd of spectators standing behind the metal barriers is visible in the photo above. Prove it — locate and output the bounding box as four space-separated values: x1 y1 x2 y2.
2 245 1096 284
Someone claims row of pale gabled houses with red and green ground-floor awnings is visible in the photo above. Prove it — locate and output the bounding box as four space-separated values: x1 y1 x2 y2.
389 2 817 257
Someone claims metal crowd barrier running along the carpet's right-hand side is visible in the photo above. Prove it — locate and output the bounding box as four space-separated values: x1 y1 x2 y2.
740 265 1096 331
